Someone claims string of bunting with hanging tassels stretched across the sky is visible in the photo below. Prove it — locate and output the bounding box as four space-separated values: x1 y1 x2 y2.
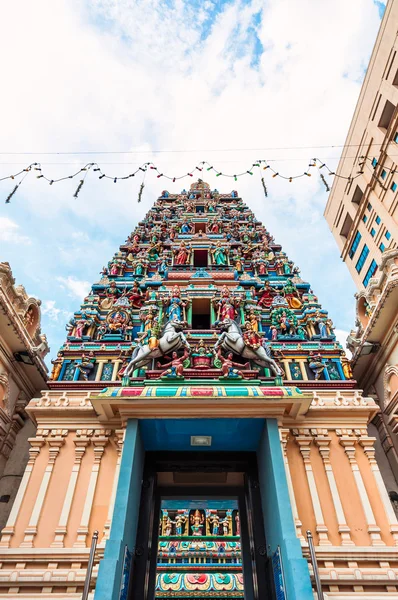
0 157 363 204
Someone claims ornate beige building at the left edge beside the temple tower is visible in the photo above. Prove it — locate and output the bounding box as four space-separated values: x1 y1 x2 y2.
0 262 49 527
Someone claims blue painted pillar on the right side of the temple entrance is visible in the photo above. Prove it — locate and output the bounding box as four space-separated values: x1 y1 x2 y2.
257 419 314 600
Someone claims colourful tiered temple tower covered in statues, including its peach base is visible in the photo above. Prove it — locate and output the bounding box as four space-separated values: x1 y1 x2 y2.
0 180 398 600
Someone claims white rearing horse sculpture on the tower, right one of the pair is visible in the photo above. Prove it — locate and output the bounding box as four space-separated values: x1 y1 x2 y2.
214 318 282 375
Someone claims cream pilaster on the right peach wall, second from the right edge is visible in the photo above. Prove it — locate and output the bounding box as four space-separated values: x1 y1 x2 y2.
336 429 385 546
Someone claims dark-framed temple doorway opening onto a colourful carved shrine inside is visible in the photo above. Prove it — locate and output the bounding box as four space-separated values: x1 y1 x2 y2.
129 451 275 600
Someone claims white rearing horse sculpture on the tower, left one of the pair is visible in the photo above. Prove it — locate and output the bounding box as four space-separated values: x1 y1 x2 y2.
124 319 190 377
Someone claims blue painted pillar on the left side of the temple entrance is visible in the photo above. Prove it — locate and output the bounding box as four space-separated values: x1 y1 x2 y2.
94 419 145 600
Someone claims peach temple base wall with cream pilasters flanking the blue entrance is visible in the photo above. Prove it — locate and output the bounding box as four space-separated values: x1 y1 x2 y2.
0 391 398 600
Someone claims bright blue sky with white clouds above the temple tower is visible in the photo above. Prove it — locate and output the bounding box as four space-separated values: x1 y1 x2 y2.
0 0 384 362
